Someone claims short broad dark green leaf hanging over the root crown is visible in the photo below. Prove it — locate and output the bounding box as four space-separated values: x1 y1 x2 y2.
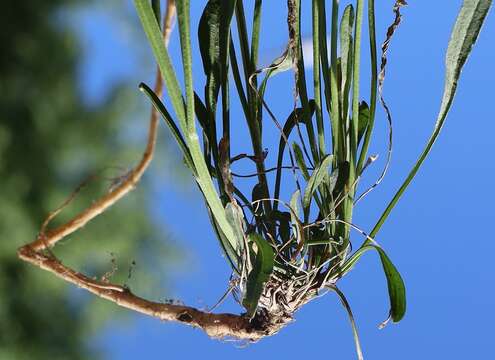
242 233 275 318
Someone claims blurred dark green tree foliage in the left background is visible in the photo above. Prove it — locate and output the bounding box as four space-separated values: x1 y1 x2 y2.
0 0 176 360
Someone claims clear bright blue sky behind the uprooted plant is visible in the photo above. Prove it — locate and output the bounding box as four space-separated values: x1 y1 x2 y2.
72 0 495 359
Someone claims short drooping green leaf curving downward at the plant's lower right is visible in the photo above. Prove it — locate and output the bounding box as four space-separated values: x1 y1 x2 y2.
341 243 406 324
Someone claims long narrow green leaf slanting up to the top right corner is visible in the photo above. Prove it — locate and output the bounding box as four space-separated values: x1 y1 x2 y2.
370 0 492 237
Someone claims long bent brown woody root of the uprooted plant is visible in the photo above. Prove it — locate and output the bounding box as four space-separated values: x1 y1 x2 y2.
17 0 276 341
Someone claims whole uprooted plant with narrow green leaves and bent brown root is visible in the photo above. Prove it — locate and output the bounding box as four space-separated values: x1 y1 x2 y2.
18 0 492 358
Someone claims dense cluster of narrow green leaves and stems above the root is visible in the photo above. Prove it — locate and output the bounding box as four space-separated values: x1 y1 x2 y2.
135 0 491 348
